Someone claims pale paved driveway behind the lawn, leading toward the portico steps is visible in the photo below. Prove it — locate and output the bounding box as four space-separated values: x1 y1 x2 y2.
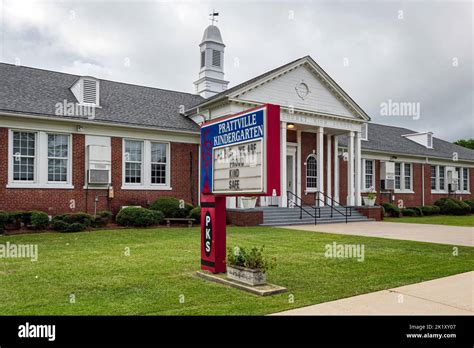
281 221 474 246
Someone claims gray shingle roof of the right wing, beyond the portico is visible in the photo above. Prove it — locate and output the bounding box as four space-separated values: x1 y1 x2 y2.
339 123 474 161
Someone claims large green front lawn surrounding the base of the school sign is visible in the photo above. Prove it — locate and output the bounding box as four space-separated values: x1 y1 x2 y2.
0 225 474 315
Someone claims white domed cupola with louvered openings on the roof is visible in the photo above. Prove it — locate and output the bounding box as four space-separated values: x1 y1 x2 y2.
194 25 229 98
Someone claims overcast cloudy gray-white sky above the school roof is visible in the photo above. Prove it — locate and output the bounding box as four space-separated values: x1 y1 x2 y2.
0 0 474 140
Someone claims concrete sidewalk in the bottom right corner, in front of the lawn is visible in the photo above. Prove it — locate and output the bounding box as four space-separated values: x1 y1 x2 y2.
272 272 474 315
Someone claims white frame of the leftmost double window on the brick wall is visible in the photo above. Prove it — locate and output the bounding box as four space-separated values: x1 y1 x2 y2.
6 128 74 189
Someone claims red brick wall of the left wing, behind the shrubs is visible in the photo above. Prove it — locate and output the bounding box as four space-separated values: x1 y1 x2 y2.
0 128 198 215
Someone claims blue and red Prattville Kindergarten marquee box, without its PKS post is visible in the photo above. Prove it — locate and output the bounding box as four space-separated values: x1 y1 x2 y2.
201 105 280 196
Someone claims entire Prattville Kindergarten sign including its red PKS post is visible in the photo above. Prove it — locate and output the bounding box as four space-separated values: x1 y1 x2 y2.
201 104 280 273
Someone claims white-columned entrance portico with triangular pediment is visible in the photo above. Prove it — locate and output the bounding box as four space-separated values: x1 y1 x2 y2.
191 56 370 208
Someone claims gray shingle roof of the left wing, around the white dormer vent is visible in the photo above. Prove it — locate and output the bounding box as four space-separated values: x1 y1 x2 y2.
0 63 203 132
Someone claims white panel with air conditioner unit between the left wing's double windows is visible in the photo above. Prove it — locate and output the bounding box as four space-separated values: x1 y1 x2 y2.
87 145 111 185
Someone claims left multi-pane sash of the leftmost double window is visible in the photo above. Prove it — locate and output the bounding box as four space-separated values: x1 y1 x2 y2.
12 132 36 181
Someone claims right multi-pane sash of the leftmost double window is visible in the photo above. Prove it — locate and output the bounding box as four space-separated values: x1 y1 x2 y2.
48 134 69 182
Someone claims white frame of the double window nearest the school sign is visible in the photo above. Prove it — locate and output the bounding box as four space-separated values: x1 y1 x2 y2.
122 138 172 190
